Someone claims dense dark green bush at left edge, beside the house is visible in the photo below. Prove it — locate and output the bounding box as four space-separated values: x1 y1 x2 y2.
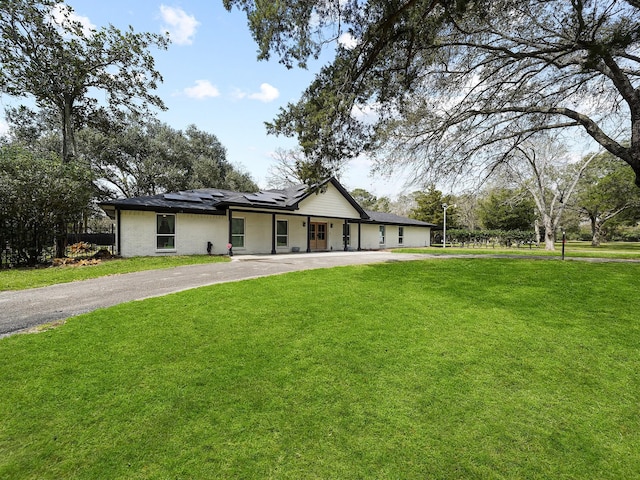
0 146 92 265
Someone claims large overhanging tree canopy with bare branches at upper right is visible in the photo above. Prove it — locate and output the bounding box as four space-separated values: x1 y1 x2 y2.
223 0 640 186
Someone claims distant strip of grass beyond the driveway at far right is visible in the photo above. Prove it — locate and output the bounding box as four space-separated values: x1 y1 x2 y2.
394 241 640 260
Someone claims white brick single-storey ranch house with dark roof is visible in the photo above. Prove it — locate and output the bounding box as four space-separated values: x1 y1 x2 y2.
101 178 434 257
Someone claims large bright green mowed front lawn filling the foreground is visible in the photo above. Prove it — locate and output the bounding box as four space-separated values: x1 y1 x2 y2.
0 258 640 479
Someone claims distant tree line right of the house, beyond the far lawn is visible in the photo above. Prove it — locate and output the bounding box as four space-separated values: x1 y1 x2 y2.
351 143 640 249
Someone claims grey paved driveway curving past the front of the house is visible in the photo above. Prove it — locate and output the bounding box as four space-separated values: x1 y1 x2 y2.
0 251 425 338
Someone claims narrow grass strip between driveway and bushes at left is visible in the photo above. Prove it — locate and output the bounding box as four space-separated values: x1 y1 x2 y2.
0 255 229 291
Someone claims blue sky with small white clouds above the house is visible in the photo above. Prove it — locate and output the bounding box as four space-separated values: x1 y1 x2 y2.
0 0 402 196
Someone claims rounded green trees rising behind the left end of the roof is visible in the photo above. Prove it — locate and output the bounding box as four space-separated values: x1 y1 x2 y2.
79 115 258 197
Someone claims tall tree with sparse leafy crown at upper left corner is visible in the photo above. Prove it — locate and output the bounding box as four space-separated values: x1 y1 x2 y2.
0 0 168 161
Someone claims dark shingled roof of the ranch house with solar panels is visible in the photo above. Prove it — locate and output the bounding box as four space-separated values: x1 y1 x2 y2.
100 178 434 227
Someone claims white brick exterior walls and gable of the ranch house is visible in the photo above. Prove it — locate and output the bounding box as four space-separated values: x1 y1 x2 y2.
119 184 430 257
